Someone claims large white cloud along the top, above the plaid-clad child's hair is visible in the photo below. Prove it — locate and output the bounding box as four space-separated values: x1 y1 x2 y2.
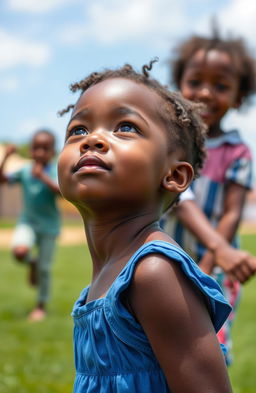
61 0 256 47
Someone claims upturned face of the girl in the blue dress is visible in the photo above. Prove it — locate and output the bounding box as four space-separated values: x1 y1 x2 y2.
58 78 178 208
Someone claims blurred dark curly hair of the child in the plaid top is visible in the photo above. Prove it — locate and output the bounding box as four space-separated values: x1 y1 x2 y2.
169 29 256 104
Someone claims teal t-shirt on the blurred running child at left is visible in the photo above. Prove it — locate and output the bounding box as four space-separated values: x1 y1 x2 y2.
8 162 60 235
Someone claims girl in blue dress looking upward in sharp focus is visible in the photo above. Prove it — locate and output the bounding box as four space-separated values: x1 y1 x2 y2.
58 65 231 393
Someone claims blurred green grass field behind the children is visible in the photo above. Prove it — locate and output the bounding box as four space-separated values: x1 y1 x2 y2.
0 235 256 393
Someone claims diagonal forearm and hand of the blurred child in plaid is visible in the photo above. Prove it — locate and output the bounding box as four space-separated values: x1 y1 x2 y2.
177 200 256 283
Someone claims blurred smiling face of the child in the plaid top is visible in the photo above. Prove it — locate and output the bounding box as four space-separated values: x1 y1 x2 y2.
180 49 239 128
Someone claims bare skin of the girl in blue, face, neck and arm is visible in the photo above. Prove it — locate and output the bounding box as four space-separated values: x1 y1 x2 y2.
59 78 231 393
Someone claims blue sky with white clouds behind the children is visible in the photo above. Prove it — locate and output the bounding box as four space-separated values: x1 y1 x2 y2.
0 0 256 178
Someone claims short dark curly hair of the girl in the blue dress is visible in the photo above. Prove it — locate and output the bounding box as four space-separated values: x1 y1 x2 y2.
59 59 206 177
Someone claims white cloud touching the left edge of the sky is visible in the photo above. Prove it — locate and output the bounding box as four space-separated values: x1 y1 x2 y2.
0 30 50 69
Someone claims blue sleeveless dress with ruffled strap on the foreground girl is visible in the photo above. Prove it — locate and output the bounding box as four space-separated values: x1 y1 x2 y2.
72 241 231 393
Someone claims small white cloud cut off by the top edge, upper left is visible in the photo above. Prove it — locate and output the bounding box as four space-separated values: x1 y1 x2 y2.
8 0 76 13
